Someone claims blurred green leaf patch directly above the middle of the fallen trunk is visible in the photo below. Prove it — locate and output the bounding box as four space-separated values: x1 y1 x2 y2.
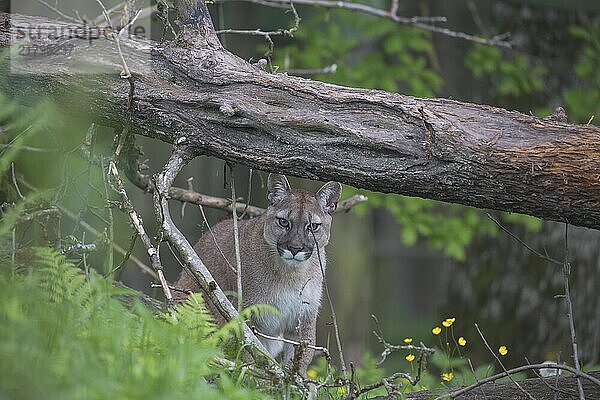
274 11 443 97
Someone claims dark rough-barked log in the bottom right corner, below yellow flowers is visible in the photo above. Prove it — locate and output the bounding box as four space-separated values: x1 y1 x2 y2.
406 372 600 400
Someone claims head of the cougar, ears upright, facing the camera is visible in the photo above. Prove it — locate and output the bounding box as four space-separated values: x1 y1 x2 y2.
263 174 342 266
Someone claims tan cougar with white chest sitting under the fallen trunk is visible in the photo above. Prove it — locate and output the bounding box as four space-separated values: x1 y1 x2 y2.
175 174 342 375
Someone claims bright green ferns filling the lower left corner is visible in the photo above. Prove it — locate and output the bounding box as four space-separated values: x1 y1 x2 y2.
0 248 274 400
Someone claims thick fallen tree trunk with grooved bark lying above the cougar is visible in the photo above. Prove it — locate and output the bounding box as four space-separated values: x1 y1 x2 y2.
0 14 600 228
